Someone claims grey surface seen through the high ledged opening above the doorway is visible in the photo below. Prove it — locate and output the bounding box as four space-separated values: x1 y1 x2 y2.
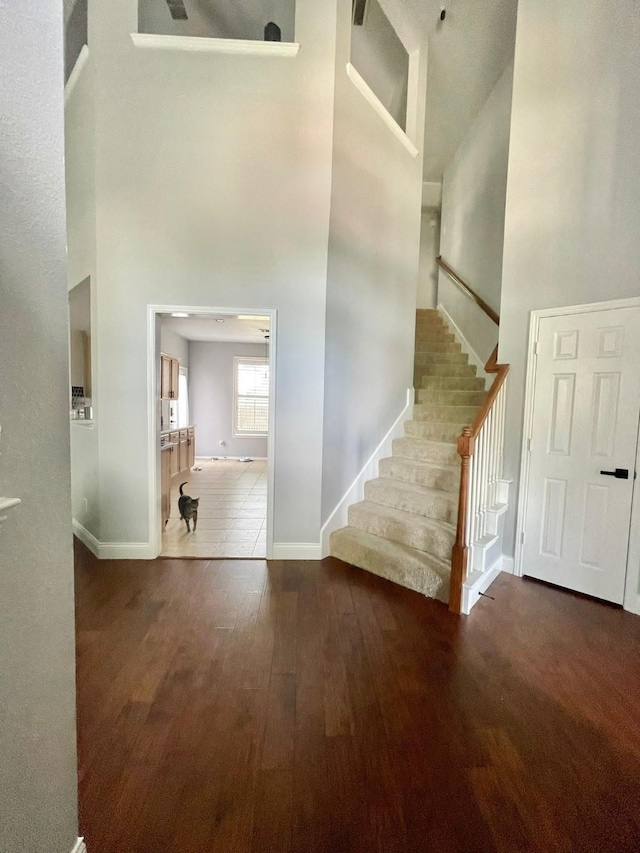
139 0 296 41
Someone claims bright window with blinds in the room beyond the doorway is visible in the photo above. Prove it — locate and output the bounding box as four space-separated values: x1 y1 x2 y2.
233 356 269 436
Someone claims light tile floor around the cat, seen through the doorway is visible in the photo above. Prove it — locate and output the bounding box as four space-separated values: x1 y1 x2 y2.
162 459 267 558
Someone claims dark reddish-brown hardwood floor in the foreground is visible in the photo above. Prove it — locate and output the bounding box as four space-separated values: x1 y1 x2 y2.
76 545 640 853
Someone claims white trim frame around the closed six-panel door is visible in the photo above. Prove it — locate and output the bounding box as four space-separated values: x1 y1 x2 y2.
513 297 640 615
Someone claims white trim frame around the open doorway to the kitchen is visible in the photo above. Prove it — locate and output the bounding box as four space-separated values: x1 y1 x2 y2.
147 305 278 560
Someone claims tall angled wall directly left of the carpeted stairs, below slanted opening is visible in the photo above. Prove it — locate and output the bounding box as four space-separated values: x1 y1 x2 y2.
322 0 425 522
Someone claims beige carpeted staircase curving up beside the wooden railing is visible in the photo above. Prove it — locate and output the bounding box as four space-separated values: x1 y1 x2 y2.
331 310 485 601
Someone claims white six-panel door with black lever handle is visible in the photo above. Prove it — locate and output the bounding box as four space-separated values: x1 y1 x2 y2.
522 308 640 604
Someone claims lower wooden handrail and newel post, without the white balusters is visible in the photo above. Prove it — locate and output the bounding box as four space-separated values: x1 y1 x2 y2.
449 345 509 613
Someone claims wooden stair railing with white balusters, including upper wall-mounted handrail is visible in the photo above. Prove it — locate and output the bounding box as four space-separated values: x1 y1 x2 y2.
437 257 509 613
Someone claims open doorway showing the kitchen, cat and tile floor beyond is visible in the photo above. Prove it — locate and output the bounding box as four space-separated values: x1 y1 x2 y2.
149 306 276 559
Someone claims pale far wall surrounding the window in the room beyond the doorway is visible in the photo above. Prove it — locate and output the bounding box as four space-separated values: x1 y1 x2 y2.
189 341 267 458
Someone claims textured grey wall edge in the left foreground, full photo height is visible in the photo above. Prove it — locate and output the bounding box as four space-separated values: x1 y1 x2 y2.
0 0 78 853
